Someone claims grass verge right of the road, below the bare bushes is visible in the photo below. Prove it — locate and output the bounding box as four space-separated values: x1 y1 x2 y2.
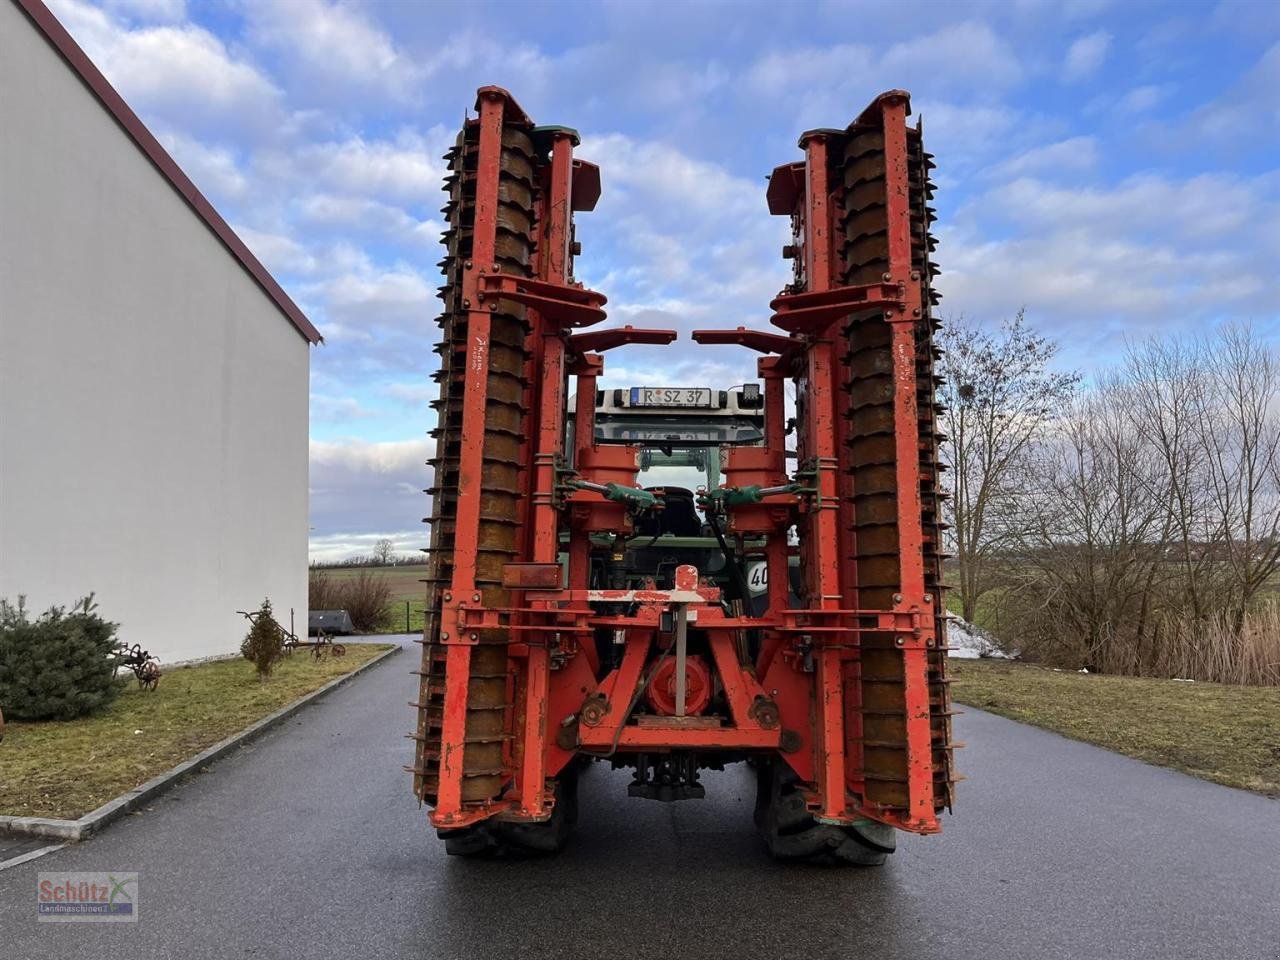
947 659 1280 797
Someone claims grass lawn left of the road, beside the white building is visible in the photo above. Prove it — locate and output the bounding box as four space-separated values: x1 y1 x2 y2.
0 644 390 819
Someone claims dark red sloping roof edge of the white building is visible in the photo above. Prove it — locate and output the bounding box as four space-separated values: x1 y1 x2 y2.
14 0 324 343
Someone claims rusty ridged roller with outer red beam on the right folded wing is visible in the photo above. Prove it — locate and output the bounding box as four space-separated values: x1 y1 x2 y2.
840 101 955 818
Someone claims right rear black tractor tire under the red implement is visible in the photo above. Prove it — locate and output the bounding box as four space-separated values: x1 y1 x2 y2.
755 762 897 867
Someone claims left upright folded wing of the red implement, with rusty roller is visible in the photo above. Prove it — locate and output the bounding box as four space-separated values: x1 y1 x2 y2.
412 94 605 827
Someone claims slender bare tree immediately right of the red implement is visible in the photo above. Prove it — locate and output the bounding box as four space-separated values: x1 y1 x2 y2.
940 310 1079 621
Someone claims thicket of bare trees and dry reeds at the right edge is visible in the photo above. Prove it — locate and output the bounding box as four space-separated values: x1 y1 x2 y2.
1002 325 1280 684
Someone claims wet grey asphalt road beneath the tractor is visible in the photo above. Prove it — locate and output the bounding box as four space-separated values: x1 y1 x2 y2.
0 648 1280 960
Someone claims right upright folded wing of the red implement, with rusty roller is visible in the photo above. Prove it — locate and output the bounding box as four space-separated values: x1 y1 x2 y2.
760 91 955 832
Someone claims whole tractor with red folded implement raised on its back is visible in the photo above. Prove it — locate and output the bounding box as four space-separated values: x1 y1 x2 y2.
411 87 956 864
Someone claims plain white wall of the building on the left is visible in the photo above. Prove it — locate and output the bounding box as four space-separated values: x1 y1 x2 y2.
0 3 308 660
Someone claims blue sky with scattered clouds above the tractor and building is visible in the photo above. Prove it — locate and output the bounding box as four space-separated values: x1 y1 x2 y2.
47 0 1280 559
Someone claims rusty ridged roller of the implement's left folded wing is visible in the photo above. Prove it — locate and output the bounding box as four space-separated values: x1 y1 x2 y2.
413 103 538 804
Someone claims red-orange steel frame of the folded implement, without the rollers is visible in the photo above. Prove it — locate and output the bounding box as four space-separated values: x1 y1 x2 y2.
430 87 941 833
